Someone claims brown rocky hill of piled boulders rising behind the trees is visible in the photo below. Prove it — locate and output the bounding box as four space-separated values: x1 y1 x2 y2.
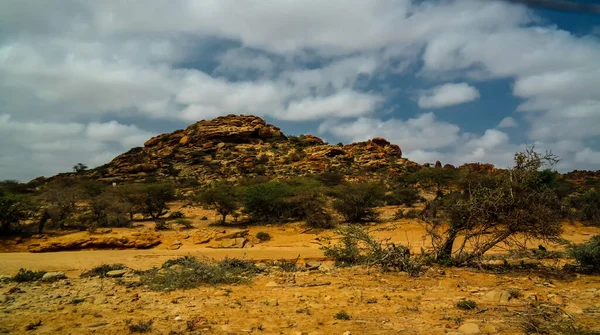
86 115 419 182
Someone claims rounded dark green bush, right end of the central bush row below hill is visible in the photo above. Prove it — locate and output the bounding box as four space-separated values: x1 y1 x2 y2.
333 182 385 223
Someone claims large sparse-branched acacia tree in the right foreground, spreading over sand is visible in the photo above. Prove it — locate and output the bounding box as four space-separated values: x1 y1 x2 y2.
424 148 561 264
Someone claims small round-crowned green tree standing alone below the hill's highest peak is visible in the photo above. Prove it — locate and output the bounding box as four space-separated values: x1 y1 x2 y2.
198 181 240 224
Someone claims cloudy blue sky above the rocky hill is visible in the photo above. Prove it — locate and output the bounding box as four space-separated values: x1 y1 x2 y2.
0 0 600 181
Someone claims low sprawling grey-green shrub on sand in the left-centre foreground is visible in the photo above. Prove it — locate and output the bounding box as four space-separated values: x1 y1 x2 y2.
140 256 259 291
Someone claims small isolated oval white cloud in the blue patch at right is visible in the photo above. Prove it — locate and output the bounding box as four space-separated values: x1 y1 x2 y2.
419 83 479 108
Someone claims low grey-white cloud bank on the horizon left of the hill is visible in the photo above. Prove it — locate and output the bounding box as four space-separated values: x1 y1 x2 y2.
0 114 153 180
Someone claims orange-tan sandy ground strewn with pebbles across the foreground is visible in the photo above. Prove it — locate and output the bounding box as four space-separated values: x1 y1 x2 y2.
0 208 600 335
